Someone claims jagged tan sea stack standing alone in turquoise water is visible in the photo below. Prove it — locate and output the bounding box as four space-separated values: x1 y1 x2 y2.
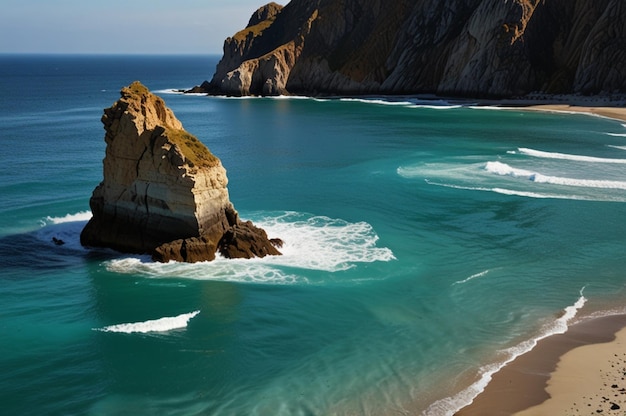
80 82 280 262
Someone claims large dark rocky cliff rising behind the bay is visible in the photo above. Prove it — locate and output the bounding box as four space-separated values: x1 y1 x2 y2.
203 0 626 97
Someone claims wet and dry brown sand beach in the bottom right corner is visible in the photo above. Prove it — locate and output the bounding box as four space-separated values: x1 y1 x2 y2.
455 315 626 416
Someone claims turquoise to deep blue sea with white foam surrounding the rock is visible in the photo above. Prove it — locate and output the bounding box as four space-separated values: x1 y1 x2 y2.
0 55 626 416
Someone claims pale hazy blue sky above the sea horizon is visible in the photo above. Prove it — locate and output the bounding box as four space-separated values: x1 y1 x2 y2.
0 0 278 54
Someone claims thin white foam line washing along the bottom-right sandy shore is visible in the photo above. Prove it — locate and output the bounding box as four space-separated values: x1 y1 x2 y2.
424 287 587 416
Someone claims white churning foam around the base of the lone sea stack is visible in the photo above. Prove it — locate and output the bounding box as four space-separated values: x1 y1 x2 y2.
105 212 395 284
